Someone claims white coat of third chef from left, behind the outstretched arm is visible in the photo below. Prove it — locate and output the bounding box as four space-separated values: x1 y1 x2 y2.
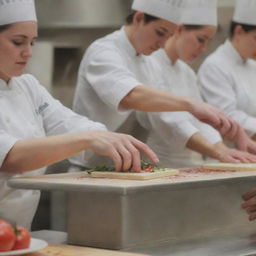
138 49 221 167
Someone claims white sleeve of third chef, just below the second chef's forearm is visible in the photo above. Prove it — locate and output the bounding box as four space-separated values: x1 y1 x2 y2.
138 112 199 150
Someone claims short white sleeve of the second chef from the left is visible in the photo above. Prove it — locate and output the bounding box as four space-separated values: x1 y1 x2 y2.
82 49 142 111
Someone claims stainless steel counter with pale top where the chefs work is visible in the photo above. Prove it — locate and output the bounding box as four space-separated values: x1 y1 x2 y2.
9 171 256 256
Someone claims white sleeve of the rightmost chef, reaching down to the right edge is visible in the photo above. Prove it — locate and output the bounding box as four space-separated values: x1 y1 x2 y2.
198 62 256 136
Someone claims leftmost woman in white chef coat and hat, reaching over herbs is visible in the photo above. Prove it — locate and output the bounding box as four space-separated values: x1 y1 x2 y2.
0 0 157 228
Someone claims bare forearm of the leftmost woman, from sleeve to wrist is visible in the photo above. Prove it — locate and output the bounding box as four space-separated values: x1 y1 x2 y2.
0 132 95 173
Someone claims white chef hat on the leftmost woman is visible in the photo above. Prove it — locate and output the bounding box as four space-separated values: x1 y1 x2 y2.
0 0 37 25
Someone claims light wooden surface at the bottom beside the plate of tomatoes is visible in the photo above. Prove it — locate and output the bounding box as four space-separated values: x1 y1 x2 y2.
24 244 146 256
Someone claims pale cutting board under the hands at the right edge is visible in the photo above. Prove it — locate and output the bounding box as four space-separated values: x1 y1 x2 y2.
202 163 256 171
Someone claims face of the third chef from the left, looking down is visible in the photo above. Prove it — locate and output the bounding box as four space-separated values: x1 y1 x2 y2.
175 25 217 63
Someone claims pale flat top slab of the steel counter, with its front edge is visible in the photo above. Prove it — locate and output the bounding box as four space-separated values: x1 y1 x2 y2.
9 170 256 195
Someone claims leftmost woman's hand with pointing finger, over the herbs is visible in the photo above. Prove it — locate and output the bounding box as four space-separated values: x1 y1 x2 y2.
85 131 159 172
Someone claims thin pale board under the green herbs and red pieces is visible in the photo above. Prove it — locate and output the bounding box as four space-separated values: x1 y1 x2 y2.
90 169 179 180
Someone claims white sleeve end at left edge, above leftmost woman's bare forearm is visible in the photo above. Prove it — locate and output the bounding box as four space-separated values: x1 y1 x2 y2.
0 130 19 166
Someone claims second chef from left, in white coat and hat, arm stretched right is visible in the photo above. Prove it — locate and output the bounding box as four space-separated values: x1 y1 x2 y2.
71 0 244 170
